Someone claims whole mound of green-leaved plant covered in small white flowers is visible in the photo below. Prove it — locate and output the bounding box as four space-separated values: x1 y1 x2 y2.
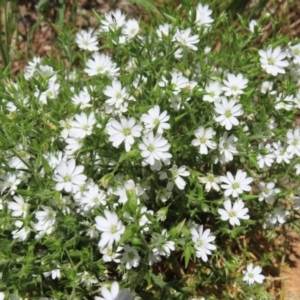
0 1 300 300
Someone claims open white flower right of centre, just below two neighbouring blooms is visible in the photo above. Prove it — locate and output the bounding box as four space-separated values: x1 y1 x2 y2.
215 97 244 130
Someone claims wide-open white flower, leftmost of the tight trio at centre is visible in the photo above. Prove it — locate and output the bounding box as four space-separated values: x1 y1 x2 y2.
106 116 143 152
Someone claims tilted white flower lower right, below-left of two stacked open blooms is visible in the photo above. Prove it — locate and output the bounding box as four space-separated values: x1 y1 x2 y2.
190 225 217 261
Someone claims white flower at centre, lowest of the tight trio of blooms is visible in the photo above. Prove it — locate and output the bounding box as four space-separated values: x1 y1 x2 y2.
139 131 172 166
